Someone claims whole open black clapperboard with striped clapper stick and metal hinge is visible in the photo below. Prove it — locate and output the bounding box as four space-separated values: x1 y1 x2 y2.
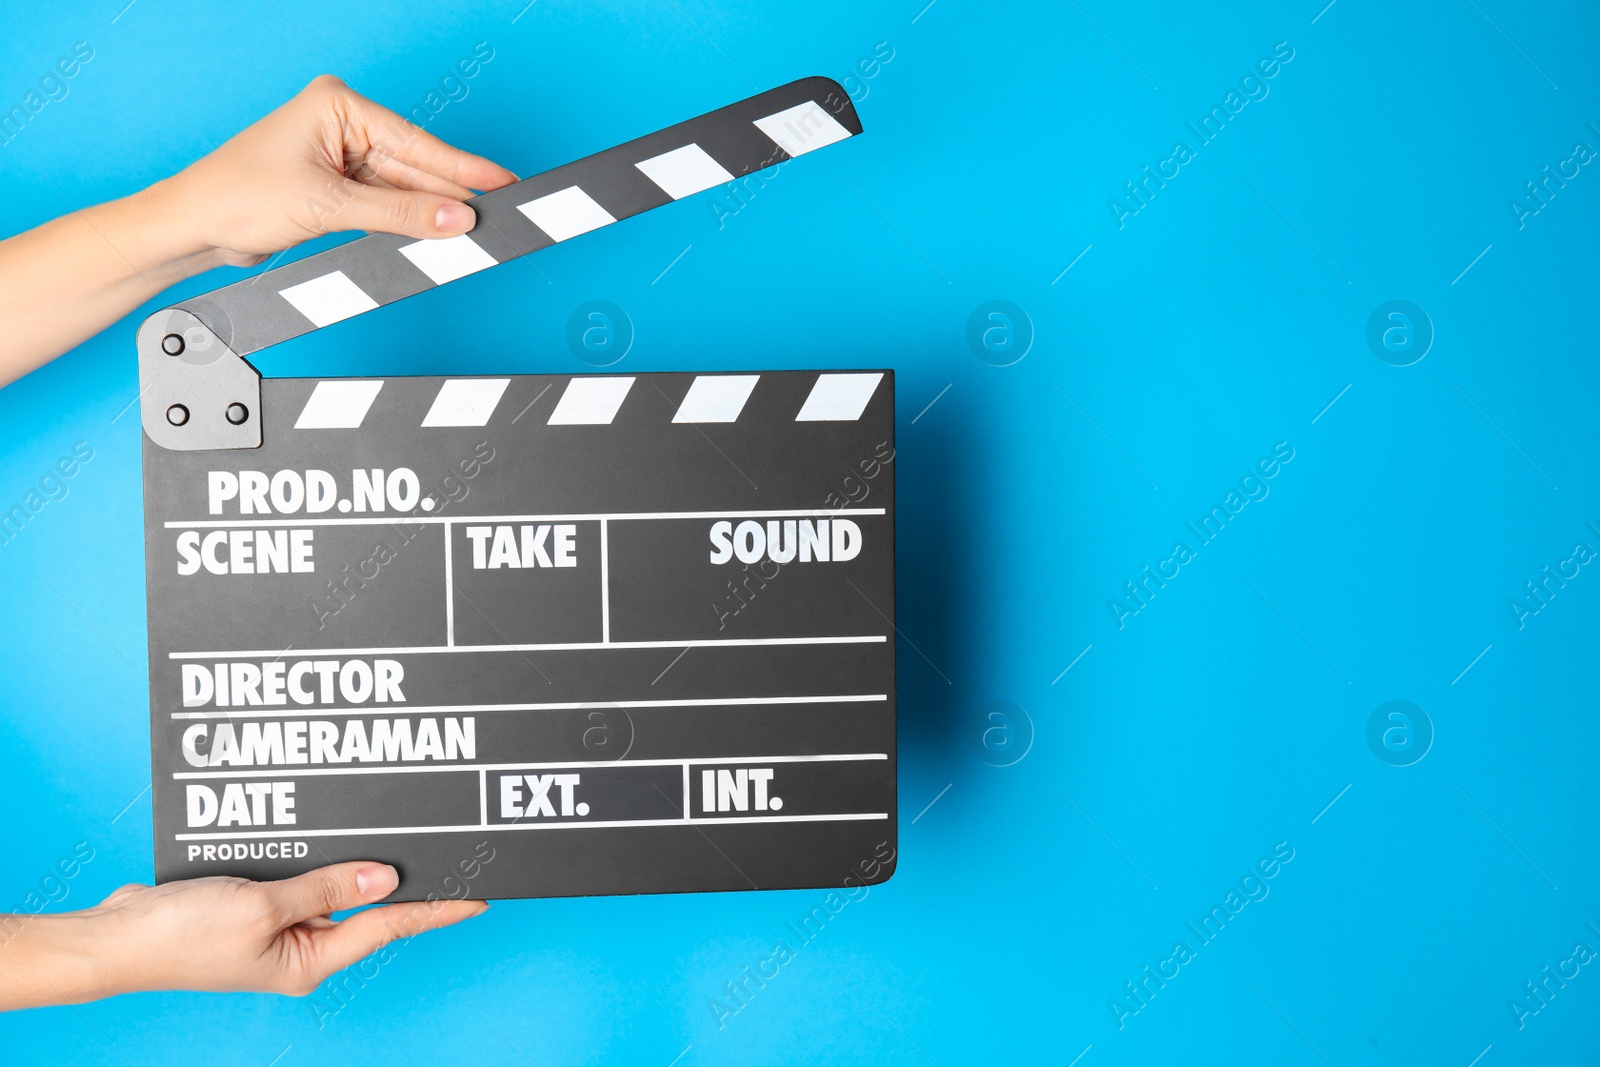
138 78 896 901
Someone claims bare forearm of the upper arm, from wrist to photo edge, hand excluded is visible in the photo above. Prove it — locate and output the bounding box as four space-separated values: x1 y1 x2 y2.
0 179 221 386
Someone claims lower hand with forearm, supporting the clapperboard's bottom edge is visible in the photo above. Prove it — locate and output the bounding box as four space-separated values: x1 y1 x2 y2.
0 862 488 1011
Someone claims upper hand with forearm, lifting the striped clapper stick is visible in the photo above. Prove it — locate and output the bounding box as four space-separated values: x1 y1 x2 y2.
0 75 517 386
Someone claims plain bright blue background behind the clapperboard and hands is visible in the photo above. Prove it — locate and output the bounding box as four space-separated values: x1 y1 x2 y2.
0 0 1600 1067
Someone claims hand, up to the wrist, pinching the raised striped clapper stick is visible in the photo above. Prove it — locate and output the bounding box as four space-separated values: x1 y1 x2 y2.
162 75 517 267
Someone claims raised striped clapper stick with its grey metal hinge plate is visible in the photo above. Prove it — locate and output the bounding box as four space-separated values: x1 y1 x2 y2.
138 78 861 451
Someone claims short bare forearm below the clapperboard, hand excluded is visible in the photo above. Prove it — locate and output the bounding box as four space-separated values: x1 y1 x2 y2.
0 912 118 1011
